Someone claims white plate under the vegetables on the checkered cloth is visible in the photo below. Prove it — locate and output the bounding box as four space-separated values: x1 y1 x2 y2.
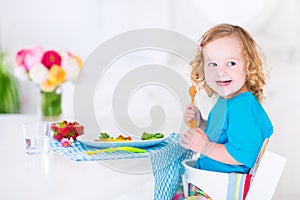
78 135 168 148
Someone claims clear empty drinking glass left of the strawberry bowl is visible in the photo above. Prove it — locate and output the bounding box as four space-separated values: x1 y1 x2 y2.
23 122 51 155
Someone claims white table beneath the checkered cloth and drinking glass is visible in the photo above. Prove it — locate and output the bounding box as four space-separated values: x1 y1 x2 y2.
0 114 154 200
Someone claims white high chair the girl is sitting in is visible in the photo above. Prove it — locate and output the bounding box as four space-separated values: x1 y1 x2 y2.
182 141 287 200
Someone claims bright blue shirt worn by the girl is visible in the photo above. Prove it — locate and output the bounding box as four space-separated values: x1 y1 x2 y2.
195 92 273 173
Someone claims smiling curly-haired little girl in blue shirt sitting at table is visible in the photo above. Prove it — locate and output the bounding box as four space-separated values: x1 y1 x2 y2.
180 24 273 198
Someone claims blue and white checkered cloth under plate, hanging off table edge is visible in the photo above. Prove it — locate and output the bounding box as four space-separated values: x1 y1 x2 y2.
50 133 192 200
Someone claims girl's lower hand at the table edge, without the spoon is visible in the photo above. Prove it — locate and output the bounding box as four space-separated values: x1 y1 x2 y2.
180 128 209 153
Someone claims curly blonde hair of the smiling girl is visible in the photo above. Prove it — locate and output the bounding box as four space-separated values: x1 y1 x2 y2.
189 24 267 102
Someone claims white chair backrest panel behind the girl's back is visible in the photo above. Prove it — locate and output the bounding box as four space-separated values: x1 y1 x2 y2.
246 151 287 200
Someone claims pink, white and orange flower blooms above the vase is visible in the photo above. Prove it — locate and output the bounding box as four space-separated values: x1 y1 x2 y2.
15 46 82 92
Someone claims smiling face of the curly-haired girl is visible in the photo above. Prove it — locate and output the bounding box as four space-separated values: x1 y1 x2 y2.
203 37 248 99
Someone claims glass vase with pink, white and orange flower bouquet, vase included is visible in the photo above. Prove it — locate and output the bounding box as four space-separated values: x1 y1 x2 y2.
15 46 82 120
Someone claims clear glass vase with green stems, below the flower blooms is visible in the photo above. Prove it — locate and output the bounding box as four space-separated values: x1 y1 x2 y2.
40 87 62 122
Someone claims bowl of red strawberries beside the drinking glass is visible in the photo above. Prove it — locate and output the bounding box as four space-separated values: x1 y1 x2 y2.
51 120 84 141
